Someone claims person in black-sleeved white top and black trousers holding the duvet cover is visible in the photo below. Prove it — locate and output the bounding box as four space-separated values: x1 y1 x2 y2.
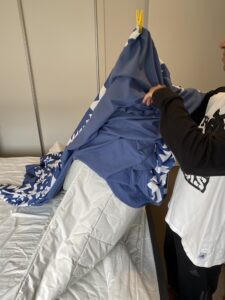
143 39 225 300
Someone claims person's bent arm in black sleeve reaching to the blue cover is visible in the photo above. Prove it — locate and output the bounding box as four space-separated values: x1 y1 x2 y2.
153 88 225 176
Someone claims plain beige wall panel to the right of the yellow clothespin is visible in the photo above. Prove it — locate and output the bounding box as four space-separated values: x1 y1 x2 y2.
148 0 225 90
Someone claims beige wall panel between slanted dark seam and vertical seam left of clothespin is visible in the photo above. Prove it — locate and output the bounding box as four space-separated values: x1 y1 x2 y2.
23 0 97 151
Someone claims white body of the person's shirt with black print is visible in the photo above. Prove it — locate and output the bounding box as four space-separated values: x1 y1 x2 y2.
166 93 225 267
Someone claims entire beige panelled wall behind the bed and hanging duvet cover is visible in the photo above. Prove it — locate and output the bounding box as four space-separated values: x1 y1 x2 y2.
3 0 225 156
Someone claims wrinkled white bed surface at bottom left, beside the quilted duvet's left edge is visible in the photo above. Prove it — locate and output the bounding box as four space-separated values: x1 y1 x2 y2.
0 193 64 300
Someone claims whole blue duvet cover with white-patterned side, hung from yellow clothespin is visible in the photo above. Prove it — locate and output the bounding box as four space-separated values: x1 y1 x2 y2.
0 28 204 207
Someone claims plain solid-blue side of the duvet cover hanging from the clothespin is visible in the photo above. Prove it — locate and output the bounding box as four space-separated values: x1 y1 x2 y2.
47 29 206 207
